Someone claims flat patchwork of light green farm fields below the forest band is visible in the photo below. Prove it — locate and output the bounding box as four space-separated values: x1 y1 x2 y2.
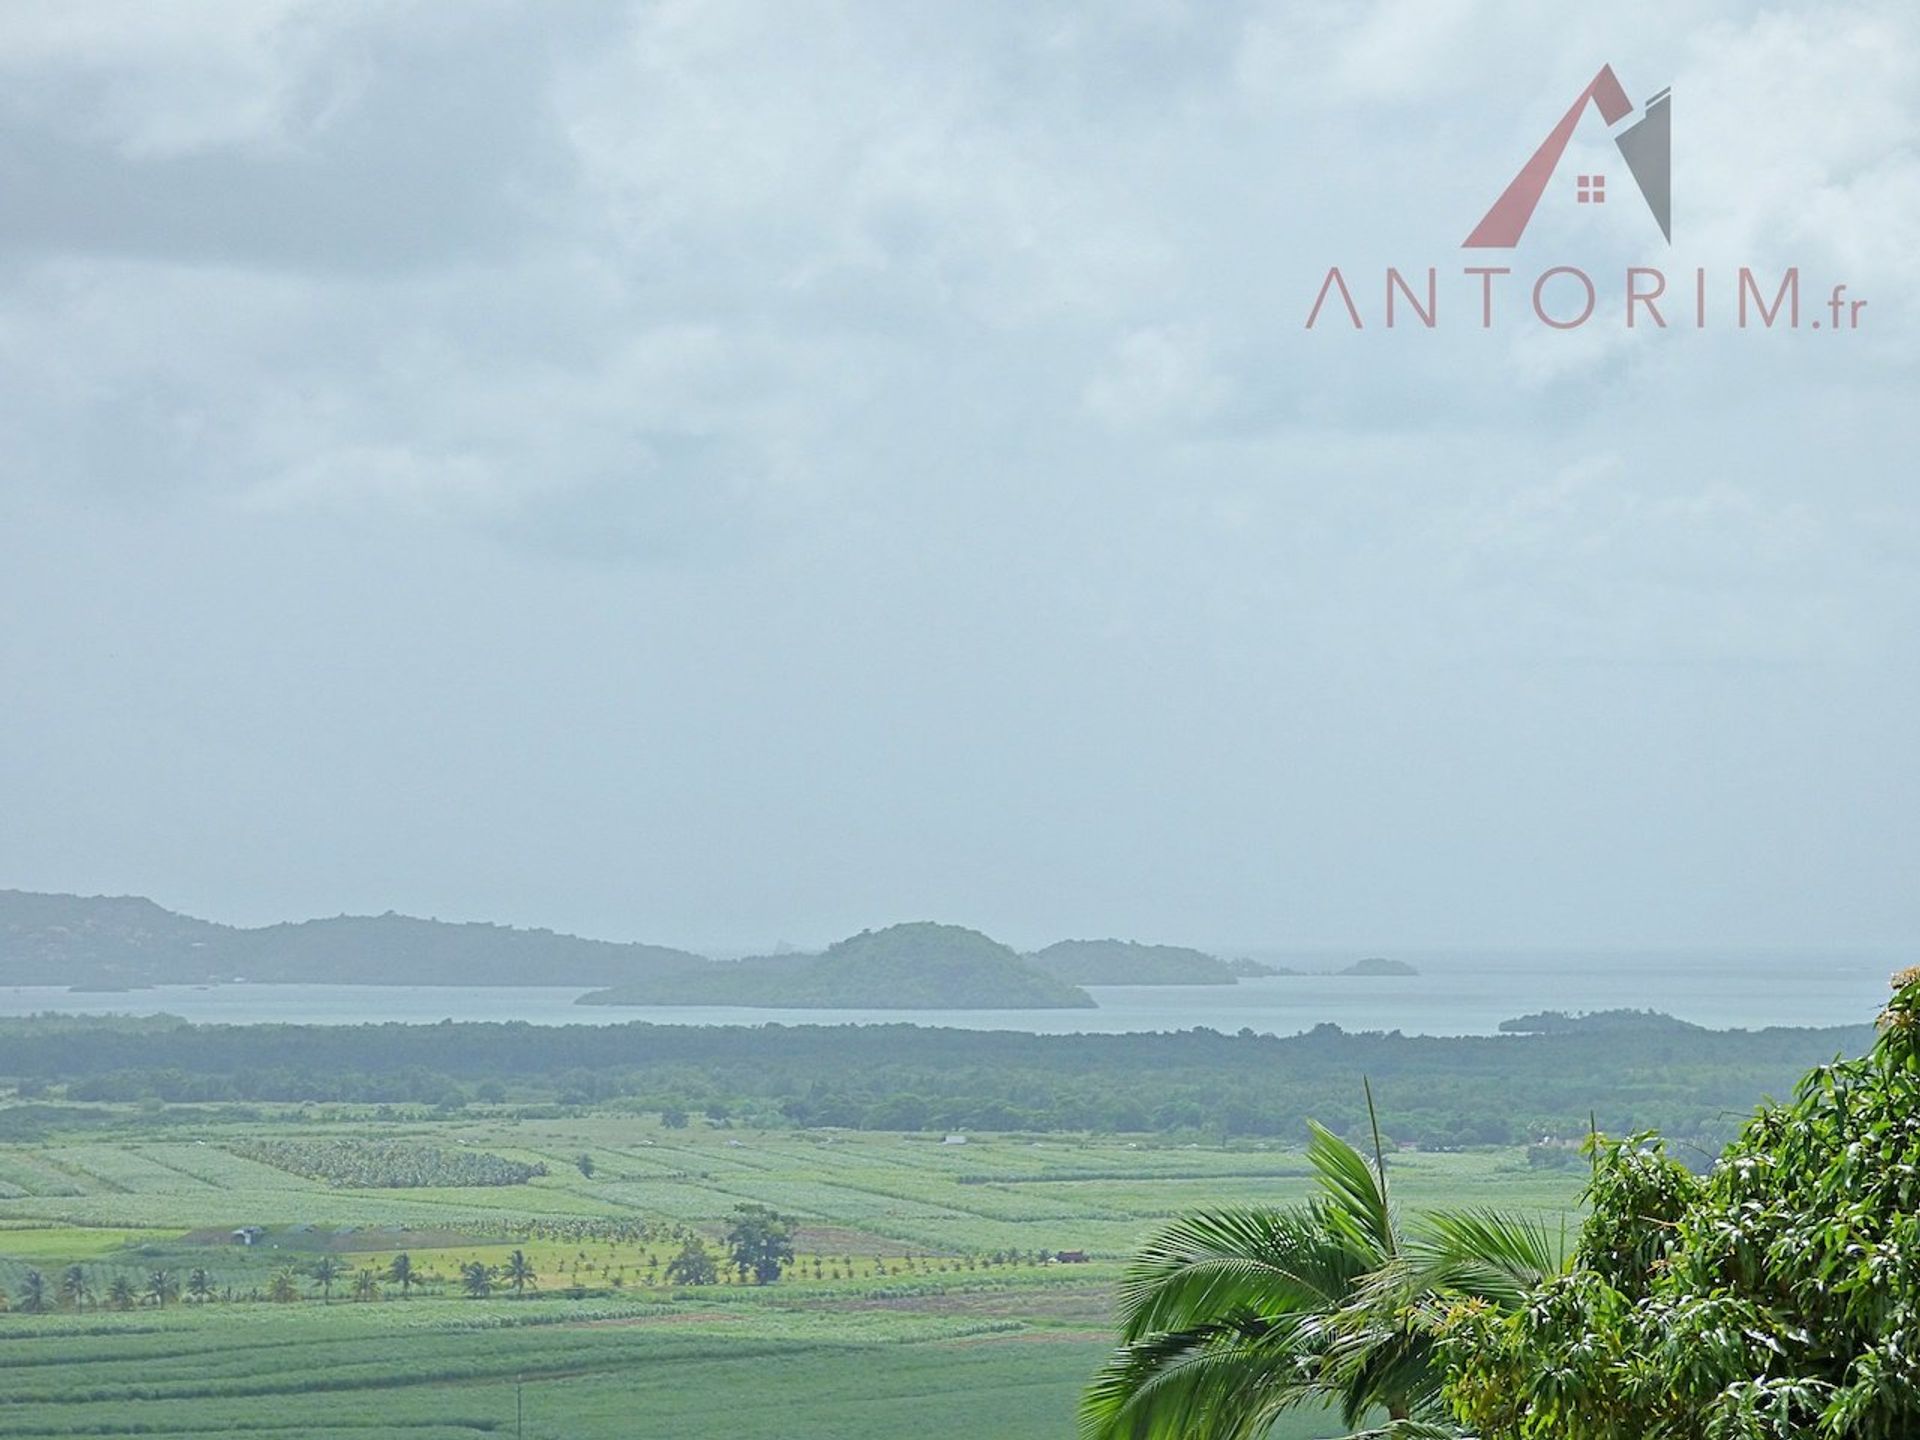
0 1108 1580 1440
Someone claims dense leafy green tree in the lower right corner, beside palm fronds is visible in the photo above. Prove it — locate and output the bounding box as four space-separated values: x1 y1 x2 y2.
1448 972 1920 1440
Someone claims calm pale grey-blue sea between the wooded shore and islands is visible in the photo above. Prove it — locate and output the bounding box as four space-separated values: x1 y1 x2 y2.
0 952 1889 1035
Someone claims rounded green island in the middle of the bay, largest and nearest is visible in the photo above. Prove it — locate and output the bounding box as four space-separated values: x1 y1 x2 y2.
578 922 1094 1010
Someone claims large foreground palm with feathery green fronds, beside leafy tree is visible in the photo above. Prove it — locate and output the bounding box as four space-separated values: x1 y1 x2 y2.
1081 1092 1559 1440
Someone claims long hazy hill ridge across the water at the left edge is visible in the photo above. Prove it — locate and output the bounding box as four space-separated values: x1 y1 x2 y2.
0 891 710 989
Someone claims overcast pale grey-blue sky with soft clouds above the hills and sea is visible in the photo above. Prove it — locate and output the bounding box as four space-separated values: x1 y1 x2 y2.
0 0 1920 963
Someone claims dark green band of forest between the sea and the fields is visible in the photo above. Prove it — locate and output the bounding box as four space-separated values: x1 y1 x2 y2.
0 1016 1872 1159
